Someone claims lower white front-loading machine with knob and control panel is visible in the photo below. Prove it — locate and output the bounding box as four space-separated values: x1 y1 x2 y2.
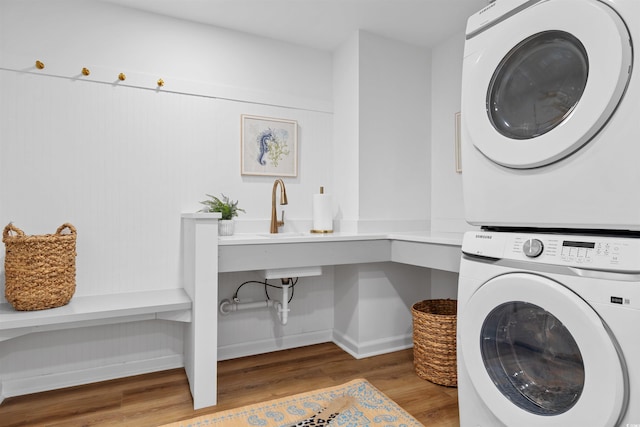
457 232 640 427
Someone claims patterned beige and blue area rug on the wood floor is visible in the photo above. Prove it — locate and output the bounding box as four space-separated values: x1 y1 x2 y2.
162 379 422 427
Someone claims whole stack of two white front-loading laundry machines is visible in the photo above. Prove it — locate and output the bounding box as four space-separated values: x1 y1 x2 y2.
457 0 640 427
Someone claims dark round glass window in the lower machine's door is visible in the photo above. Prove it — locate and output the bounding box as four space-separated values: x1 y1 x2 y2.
480 301 585 415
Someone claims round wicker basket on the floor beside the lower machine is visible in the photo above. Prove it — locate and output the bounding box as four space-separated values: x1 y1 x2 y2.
411 299 458 387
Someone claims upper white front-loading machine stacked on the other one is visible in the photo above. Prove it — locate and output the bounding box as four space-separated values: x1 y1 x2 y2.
461 0 640 230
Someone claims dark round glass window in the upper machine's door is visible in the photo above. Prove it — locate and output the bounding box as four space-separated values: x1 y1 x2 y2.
487 31 589 140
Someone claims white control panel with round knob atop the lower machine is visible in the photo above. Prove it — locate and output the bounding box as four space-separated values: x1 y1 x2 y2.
462 231 640 272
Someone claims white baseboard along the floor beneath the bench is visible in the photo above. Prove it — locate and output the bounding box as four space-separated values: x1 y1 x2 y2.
0 354 184 402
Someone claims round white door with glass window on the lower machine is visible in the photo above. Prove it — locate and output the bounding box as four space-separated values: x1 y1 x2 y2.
458 273 628 427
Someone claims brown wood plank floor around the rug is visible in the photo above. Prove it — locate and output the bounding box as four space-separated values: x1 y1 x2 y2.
0 343 459 427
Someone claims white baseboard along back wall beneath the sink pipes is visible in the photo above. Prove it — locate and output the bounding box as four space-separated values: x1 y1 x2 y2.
218 329 333 360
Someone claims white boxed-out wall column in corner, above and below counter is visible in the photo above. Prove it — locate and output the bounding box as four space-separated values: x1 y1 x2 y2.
333 31 430 357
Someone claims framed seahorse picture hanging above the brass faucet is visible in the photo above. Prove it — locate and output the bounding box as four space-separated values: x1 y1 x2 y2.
240 114 298 177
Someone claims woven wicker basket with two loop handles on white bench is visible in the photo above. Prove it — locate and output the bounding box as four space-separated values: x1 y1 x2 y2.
2 224 76 311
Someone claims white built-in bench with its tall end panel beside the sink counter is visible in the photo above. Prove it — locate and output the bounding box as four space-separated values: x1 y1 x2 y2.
0 213 220 409
